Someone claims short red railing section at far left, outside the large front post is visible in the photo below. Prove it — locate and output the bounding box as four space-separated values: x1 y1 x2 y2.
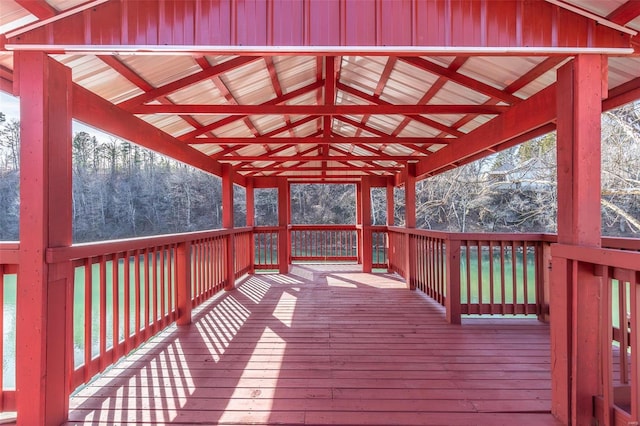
0 243 20 412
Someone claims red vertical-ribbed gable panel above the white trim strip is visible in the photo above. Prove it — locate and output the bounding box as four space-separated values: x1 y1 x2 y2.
9 0 629 50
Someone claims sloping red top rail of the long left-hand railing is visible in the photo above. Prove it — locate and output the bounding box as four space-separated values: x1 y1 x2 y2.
46 227 252 263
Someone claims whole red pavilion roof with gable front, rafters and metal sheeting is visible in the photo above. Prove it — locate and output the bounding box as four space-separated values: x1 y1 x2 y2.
0 0 640 186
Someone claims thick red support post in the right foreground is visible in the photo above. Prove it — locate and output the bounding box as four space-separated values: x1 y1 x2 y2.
550 55 606 424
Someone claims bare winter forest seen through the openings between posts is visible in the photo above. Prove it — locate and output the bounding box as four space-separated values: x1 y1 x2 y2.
0 104 640 242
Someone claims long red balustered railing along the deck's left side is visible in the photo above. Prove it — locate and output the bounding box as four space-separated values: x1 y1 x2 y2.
47 228 251 388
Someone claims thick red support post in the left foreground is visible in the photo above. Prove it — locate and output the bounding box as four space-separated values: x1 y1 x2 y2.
15 52 73 425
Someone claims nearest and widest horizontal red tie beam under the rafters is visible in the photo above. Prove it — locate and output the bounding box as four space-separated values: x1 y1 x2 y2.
136 101 509 116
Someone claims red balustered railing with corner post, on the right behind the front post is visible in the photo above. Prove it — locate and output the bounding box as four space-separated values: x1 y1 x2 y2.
389 228 550 322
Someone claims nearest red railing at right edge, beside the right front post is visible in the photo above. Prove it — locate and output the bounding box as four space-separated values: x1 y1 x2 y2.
553 245 640 425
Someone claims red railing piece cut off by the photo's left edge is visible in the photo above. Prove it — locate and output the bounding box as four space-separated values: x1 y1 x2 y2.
0 243 20 412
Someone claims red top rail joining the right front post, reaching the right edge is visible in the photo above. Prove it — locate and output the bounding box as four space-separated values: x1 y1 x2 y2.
551 244 640 272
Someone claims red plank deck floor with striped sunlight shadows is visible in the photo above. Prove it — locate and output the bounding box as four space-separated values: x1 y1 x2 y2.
69 265 559 426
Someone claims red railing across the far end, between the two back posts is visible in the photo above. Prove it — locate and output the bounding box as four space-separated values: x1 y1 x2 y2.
290 225 358 261
